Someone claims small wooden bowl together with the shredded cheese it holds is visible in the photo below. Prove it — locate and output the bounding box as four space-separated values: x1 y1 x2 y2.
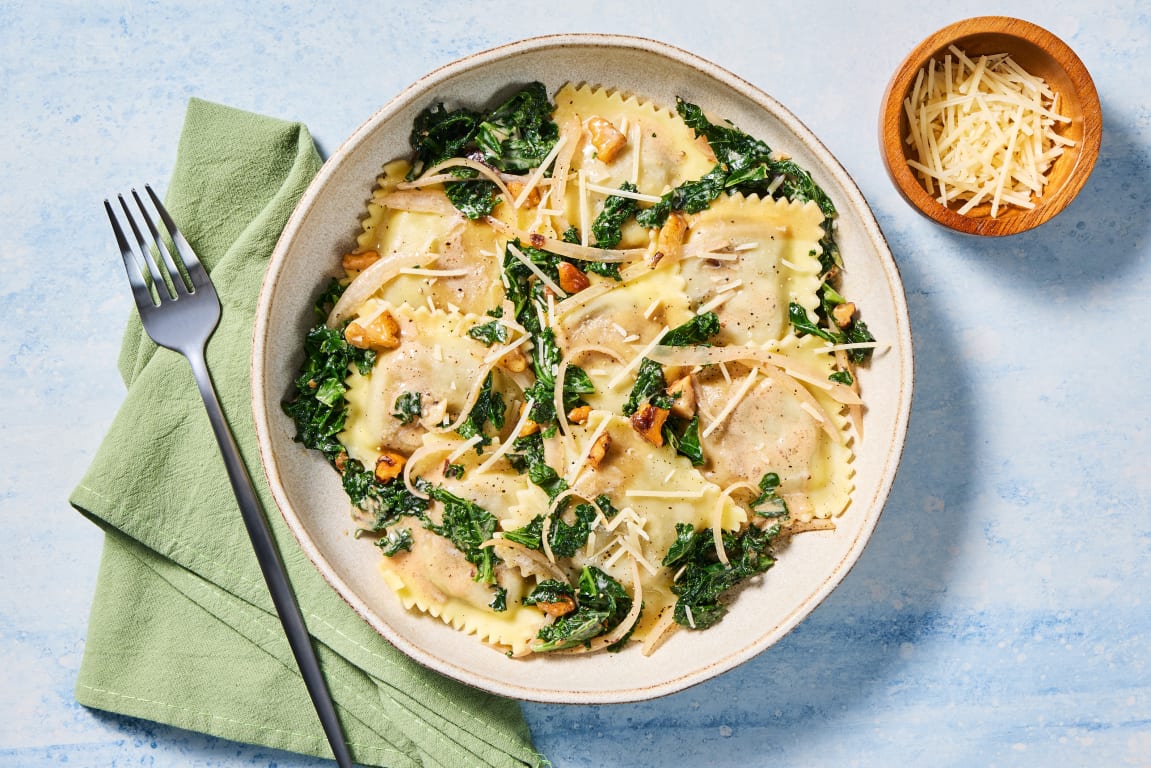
879 16 1103 236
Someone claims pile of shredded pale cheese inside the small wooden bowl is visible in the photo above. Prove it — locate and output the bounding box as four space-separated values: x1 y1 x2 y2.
904 46 1074 218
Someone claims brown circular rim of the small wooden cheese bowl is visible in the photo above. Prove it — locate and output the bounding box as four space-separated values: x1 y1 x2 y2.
878 16 1103 236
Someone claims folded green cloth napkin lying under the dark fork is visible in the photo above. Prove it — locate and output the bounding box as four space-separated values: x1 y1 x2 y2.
70 99 546 768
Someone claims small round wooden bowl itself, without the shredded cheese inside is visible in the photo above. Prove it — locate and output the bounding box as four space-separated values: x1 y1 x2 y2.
879 16 1103 236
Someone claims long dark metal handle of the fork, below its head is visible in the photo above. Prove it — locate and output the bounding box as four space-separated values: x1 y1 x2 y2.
184 349 352 768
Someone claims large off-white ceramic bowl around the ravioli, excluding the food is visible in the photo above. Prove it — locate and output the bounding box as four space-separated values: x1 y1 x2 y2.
252 35 913 704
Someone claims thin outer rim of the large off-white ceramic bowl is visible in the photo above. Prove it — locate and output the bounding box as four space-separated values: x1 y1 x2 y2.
251 32 914 704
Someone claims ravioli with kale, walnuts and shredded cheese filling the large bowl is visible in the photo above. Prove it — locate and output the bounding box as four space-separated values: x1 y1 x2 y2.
285 84 875 657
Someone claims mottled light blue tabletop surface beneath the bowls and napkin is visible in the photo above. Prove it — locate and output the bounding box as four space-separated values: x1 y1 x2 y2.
0 0 1151 768
